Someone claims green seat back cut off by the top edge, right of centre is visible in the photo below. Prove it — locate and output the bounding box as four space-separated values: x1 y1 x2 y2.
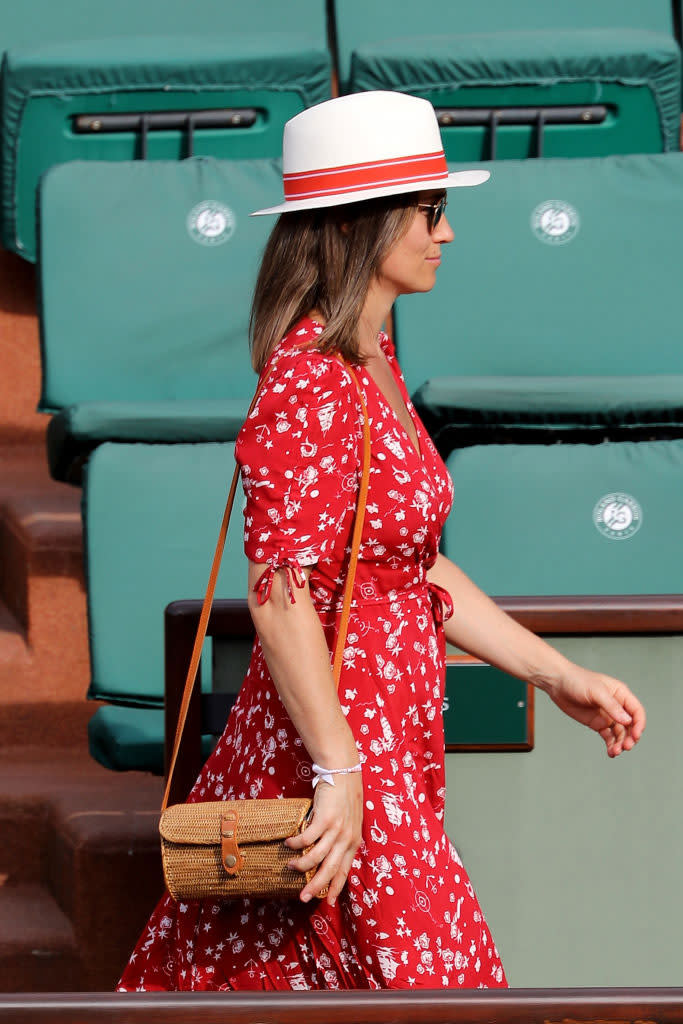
335 0 673 83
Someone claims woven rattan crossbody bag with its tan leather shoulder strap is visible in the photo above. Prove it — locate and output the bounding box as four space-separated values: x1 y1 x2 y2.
159 350 370 899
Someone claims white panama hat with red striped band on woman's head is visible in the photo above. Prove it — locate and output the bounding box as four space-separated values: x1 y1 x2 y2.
252 91 490 217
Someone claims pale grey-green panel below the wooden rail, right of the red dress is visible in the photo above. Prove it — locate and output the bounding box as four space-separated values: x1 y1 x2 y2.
446 637 683 988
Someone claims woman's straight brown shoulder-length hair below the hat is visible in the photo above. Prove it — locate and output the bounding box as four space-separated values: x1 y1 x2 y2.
249 193 418 373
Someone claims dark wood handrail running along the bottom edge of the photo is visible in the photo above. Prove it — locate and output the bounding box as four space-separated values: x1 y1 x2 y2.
0 988 683 1024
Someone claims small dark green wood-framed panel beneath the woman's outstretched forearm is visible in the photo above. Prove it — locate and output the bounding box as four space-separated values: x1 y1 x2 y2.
443 662 532 750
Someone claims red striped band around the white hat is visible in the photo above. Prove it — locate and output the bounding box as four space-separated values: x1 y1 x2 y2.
283 150 449 200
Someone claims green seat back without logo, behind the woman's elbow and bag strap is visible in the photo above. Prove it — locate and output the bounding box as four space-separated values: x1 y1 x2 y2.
84 443 247 706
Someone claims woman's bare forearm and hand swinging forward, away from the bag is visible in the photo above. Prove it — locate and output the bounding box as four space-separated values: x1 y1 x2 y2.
428 555 645 757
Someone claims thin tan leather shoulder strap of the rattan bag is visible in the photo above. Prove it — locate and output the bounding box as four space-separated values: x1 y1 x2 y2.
161 356 370 813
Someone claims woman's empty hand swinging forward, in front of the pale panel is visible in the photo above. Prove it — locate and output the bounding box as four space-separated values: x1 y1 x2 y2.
544 664 645 758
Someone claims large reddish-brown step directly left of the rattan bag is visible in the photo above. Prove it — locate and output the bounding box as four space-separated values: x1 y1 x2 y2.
0 748 164 991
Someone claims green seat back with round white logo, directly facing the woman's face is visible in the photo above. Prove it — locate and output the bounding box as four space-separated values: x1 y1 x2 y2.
394 154 683 400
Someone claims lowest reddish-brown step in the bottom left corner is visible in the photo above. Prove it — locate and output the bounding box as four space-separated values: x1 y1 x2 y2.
0 885 81 992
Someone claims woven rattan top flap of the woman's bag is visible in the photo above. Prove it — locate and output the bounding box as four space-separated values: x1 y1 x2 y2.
159 797 312 846
